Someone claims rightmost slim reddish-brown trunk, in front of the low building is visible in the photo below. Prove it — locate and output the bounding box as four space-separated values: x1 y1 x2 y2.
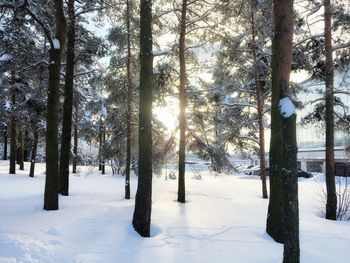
323 0 337 220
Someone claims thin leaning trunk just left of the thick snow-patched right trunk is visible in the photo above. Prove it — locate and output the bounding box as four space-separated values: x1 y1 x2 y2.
251 5 267 199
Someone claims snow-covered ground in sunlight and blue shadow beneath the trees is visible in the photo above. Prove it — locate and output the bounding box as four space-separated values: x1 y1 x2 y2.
0 161 350 263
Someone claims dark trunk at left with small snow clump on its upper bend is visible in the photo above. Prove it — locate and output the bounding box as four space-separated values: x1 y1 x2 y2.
44 0 66 210
